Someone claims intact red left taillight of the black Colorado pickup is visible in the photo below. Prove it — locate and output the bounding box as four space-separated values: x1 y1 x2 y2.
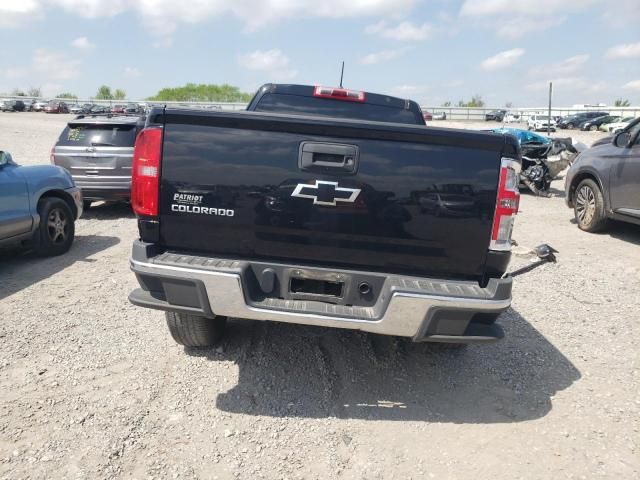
131 127 162 216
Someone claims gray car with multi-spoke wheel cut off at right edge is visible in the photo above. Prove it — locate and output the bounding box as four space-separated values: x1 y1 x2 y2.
565 119 640 232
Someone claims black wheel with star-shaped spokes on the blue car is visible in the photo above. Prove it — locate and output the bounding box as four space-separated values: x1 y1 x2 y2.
34 197 75 257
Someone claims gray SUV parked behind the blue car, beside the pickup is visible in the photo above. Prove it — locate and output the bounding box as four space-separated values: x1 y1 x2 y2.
51 115 144 209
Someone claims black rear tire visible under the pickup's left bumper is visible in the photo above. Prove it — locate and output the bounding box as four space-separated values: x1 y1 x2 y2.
166 312 227 347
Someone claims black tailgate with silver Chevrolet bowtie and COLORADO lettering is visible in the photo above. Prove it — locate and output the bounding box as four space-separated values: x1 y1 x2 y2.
159 110 505 278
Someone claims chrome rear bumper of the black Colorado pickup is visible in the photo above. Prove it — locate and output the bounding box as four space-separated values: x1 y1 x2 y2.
129 242 512 342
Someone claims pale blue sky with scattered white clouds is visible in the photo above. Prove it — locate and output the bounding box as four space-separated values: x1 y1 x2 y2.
0 0 640 107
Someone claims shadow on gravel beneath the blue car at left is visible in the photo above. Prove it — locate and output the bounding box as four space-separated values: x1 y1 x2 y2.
0 235 120 300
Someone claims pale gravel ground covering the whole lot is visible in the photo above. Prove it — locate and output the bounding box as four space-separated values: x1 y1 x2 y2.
0 113 640 479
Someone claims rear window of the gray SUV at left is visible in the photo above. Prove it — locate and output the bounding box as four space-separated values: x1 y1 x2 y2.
58 124 136 147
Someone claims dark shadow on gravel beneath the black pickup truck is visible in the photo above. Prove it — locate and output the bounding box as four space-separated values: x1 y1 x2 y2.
187 310 580 423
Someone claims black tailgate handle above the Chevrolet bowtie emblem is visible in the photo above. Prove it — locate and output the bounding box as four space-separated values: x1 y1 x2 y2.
298 142 360 173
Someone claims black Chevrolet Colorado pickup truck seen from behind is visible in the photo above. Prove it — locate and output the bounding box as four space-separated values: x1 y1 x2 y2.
130 84 520 347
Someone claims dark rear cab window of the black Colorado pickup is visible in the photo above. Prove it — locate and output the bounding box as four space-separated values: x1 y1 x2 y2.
255 93 424 125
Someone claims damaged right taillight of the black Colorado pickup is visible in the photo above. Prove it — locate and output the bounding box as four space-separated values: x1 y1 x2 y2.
489 158 520 250
